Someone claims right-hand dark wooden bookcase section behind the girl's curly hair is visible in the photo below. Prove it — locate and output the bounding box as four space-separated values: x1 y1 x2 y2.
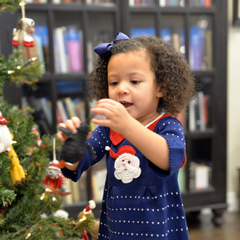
121 0 227 225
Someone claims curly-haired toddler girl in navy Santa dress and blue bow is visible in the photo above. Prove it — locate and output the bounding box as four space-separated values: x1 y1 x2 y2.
57 33 195 240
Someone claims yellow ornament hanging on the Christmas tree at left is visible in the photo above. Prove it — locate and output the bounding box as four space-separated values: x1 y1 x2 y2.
7 134 25 184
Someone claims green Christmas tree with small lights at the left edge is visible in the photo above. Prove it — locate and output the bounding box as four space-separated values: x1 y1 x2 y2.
0 0 91 240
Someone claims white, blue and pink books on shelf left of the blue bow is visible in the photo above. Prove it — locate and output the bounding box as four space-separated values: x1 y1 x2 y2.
53 25 83 73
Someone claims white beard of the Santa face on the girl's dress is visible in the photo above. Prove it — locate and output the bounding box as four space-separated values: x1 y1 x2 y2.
114 165 140 183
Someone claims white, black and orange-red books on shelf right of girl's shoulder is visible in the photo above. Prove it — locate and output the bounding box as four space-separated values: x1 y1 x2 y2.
189 91 211 131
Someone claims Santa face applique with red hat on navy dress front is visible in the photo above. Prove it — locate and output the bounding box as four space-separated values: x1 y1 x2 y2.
106 145 141 183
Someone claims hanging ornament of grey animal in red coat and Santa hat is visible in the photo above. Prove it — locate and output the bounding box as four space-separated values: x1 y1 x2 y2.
43 139 71 196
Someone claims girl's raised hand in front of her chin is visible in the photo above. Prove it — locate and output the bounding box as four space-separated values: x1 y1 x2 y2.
91 98 132 133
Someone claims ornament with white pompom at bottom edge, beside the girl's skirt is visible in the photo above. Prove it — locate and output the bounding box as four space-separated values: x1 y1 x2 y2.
74 200 100 240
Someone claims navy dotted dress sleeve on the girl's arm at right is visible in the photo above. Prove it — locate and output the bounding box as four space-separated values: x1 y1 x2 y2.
156 116 186 175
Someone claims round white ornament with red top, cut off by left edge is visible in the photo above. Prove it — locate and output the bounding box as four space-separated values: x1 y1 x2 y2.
0 111 12 153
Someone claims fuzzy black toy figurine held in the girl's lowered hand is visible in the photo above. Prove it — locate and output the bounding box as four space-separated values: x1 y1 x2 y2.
59 122 96 168
